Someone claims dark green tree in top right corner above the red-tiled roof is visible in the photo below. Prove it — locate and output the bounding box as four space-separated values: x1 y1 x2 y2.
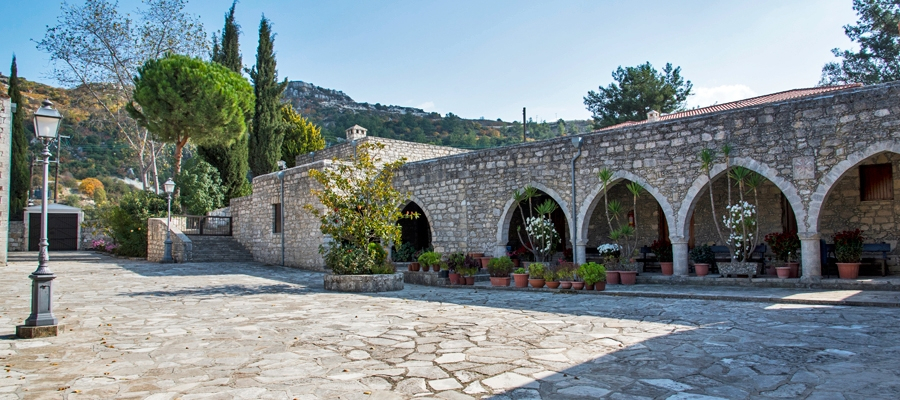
819 0 900 85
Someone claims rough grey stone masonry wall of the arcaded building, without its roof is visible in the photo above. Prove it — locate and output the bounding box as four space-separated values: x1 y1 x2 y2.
232 83 900 276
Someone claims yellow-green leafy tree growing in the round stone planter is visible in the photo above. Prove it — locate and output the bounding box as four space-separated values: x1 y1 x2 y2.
305 143 419 275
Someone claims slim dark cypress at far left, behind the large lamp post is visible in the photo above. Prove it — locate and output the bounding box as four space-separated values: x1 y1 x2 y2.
7 56 31 221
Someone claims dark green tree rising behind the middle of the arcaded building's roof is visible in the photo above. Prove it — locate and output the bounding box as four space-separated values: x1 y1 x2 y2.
584 62 693 129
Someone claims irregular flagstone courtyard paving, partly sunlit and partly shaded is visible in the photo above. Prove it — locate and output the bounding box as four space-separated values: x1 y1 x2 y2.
0 253 900 400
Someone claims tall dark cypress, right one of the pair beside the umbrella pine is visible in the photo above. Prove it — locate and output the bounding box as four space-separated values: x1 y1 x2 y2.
250 16 287 175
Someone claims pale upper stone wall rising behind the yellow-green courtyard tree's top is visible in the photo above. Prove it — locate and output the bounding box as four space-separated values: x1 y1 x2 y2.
296 136 468 166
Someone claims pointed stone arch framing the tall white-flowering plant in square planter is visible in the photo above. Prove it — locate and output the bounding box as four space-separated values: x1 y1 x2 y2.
674 157 809 238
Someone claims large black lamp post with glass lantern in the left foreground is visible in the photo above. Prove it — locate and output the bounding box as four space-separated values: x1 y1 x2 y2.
16 100 62 338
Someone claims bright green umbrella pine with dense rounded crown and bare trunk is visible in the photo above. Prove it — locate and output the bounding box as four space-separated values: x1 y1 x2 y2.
127 55 253 175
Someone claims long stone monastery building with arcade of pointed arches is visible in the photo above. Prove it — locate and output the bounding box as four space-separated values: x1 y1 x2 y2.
231 83 900 280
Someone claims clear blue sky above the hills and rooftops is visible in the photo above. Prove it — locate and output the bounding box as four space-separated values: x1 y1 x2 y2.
0 0 856 121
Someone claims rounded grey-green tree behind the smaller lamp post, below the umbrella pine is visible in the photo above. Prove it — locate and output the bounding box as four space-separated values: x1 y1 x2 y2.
174 157 225 215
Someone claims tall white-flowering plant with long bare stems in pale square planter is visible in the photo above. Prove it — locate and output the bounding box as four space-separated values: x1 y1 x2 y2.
700 144 763 276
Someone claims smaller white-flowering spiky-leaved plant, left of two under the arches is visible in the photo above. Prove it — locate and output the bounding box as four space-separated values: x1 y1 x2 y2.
513 186 560 262
